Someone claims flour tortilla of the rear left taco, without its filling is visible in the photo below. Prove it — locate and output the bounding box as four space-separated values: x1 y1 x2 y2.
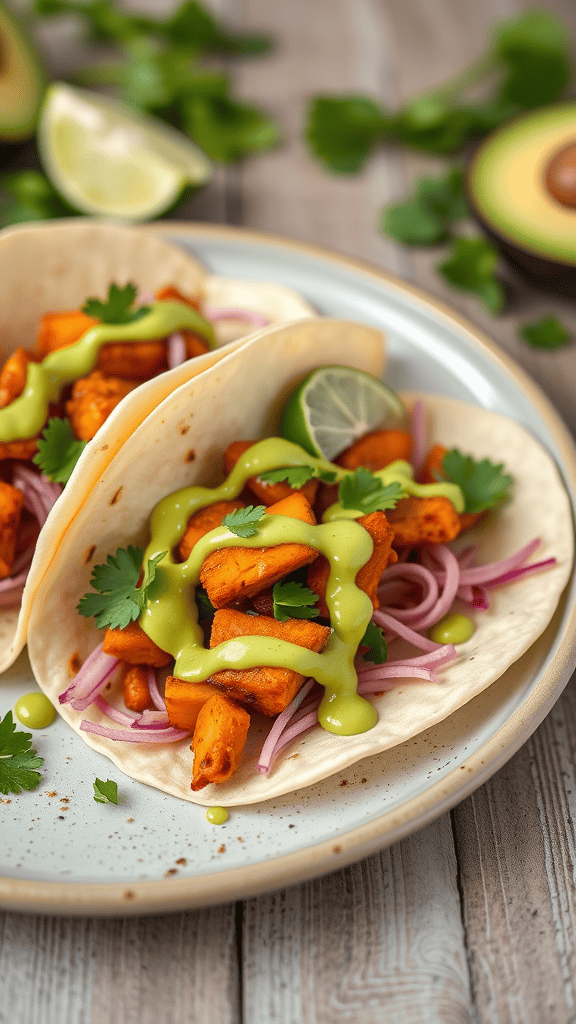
0 218 313 672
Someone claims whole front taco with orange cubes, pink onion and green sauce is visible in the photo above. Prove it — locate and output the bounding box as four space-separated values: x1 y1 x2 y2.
29 319 573 806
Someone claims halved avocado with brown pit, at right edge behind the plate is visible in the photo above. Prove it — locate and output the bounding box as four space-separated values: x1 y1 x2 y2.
467 101 576 294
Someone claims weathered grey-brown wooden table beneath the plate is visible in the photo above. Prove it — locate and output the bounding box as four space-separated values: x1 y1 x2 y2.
0 0 576 1024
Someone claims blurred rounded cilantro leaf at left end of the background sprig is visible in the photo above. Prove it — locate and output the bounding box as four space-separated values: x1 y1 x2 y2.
305 95 389 174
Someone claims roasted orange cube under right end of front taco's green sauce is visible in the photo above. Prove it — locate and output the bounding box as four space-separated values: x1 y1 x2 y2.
387 497 461 548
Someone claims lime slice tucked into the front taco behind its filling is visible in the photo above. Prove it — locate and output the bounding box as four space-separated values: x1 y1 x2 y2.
282 367 406 460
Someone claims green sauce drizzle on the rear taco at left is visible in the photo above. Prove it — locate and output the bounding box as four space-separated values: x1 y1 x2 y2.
0 301 215 441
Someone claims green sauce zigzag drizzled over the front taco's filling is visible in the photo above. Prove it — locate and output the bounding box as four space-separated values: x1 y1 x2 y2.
139 437 459 735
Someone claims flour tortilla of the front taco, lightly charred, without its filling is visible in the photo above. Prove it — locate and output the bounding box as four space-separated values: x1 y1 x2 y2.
29 321 573 806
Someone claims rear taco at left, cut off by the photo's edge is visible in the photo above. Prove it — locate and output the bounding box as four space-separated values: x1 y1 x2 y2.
0 220 311 671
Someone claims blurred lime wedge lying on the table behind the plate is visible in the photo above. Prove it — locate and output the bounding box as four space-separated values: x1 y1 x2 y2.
38 82 212 220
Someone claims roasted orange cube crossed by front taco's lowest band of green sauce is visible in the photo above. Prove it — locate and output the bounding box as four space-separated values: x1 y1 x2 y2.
210 608 330 717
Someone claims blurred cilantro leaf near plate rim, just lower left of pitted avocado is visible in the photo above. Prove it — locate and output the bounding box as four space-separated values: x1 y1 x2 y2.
438 238 504 314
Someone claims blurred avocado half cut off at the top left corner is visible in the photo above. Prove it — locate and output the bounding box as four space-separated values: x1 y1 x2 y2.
0 4 45 142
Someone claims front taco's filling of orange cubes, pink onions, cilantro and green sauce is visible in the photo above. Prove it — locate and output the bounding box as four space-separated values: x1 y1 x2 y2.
59 372 557 793
